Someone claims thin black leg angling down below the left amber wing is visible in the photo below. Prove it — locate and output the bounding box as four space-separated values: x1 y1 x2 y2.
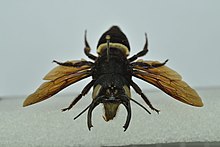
62 79 95 111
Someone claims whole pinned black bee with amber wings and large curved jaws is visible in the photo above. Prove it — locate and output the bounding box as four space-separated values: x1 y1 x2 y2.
23 26 203 131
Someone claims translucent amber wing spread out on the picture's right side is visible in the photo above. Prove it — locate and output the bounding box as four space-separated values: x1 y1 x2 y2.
133 61 203 107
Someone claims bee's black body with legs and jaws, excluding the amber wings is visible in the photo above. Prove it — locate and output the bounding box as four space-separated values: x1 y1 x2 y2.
59 26 163 130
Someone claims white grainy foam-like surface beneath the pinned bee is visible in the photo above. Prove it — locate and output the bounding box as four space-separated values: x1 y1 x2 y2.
0 88 220 147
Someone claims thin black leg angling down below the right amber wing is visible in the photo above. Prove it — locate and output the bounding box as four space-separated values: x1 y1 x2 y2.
130 81 160 113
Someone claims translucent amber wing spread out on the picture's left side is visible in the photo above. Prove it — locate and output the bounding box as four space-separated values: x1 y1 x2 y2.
23 61 91 107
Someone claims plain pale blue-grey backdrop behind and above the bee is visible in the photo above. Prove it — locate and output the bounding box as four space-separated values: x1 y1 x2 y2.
0 0 220 96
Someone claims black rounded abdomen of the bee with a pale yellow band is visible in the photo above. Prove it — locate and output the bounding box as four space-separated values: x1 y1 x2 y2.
97 26 130 56
